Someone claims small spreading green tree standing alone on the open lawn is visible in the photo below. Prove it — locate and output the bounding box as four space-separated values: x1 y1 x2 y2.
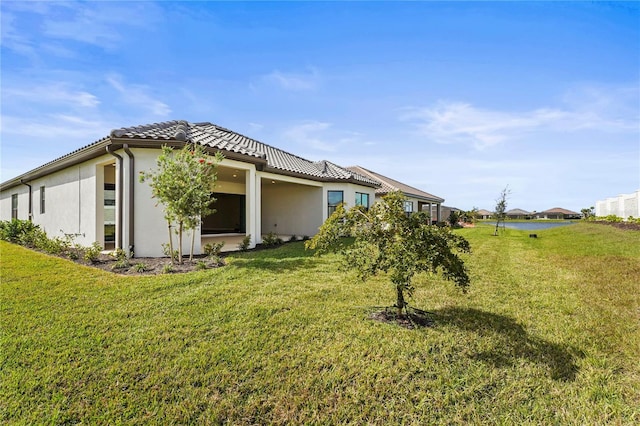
305 192 470 315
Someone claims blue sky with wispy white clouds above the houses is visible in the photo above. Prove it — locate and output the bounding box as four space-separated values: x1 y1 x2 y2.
0 1 640 211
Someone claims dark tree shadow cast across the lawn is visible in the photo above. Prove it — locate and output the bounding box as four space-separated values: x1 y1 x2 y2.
431 307 583 381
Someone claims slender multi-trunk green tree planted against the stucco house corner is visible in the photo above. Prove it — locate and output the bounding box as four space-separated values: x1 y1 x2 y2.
140 144 223 263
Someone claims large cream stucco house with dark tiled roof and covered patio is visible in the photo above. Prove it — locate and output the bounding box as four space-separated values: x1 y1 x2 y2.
0 121 381 257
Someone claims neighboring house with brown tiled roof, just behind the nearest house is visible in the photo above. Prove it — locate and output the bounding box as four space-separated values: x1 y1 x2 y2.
347 166 449 222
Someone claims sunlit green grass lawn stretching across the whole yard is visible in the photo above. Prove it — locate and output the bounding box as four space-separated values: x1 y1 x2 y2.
0 223 640 425
